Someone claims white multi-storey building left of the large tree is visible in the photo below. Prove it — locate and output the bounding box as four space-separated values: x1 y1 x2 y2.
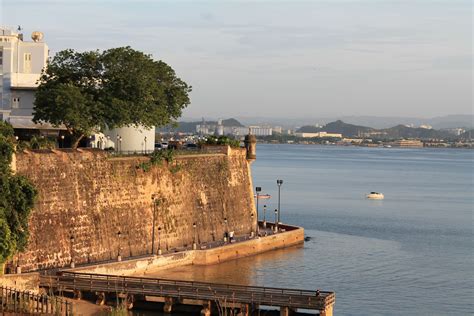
0 27 49 124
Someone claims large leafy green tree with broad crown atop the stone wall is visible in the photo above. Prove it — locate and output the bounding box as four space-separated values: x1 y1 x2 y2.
33 47 191 148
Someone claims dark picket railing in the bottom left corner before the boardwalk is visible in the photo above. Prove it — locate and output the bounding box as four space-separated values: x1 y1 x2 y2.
0 286 73 316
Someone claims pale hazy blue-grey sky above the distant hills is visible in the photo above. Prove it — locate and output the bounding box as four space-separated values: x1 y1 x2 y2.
0 0 473 118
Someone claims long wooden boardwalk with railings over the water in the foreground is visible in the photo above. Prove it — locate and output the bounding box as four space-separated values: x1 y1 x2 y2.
41 271 335 315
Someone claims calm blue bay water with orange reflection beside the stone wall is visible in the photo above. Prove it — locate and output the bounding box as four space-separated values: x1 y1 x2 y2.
136 145 474 315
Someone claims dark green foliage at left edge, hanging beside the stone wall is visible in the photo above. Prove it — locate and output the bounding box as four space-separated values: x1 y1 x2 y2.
0 121 37 273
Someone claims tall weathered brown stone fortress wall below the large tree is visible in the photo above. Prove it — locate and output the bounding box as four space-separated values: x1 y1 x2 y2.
15 149 256 271
